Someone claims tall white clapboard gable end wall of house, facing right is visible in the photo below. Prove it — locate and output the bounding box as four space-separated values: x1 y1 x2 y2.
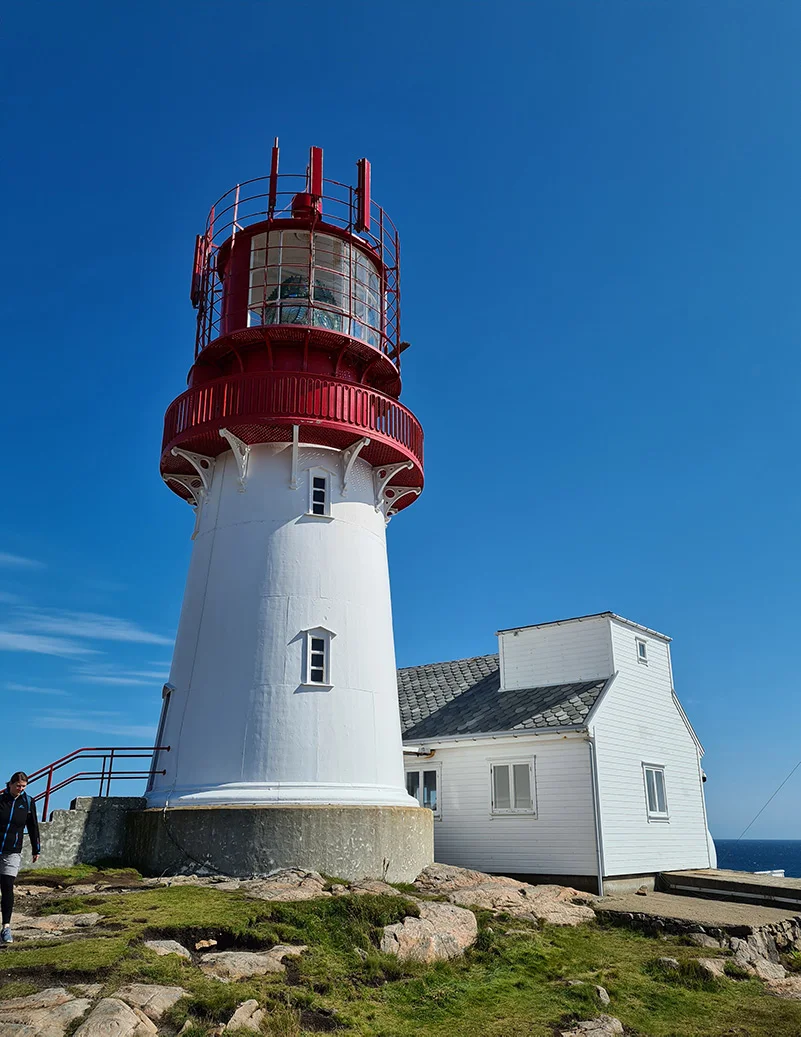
592 619 710 876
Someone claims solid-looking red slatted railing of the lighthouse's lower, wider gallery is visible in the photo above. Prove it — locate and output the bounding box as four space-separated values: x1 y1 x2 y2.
164 371 423 469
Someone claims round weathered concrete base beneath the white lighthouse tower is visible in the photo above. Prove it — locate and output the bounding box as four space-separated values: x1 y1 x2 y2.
126 806 434 882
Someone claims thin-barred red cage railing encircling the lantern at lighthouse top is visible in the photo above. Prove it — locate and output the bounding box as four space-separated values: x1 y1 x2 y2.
192 173 401 362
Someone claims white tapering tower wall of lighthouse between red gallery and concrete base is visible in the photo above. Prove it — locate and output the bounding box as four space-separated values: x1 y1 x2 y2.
147 444 417 807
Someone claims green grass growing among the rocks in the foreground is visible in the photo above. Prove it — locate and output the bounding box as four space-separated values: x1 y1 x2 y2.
0 877 801 1037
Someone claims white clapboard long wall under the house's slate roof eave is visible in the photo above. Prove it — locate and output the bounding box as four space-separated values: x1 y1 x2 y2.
406 736 598 875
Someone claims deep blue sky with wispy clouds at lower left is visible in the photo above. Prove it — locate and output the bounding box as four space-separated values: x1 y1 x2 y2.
0 0 801 838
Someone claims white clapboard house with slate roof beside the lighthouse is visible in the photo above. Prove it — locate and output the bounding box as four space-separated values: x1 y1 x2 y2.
398 612 716 892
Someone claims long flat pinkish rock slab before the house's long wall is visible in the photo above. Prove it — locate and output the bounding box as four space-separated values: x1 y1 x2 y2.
414 864 596 925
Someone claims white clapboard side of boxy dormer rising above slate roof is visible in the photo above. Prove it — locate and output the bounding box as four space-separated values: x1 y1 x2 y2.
498 616 613 691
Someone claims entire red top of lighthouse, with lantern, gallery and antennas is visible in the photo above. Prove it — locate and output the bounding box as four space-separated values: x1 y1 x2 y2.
161 140 423 514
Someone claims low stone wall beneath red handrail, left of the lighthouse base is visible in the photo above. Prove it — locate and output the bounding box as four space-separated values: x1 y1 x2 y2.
22 795 145 868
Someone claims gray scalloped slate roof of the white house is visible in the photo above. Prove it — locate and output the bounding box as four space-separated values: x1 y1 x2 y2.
397 655 609 741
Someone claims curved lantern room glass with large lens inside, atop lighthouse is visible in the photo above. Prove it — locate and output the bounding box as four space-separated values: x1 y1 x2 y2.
248 230 382 348
